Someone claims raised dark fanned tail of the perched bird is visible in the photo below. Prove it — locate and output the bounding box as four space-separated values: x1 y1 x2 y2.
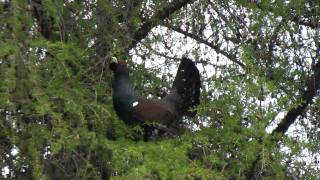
173 57 201 117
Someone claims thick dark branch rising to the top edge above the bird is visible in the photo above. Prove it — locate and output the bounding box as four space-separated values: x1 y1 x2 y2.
127 0 193 50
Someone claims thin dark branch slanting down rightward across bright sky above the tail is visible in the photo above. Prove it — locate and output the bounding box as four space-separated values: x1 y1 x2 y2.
165 24 246 69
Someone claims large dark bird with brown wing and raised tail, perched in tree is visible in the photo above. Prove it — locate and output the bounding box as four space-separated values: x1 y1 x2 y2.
109 57 201 127
